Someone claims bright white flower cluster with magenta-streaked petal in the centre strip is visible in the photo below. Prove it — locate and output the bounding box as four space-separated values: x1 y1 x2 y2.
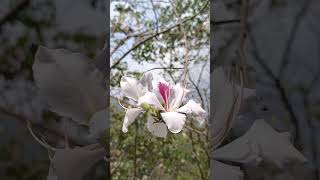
120 74 207 137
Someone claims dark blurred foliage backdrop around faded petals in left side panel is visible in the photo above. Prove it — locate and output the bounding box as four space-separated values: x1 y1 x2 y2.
0 0 108 180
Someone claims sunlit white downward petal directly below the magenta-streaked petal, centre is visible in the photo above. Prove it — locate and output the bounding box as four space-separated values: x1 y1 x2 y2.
161 112 186 133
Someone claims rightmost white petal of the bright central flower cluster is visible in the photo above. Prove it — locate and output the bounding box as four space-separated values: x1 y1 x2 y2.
176 100 207 124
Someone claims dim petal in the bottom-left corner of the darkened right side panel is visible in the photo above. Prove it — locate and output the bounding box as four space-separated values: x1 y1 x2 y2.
210 160 244 180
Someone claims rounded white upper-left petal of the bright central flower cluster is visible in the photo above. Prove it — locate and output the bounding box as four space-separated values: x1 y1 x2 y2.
120 76 144 100
